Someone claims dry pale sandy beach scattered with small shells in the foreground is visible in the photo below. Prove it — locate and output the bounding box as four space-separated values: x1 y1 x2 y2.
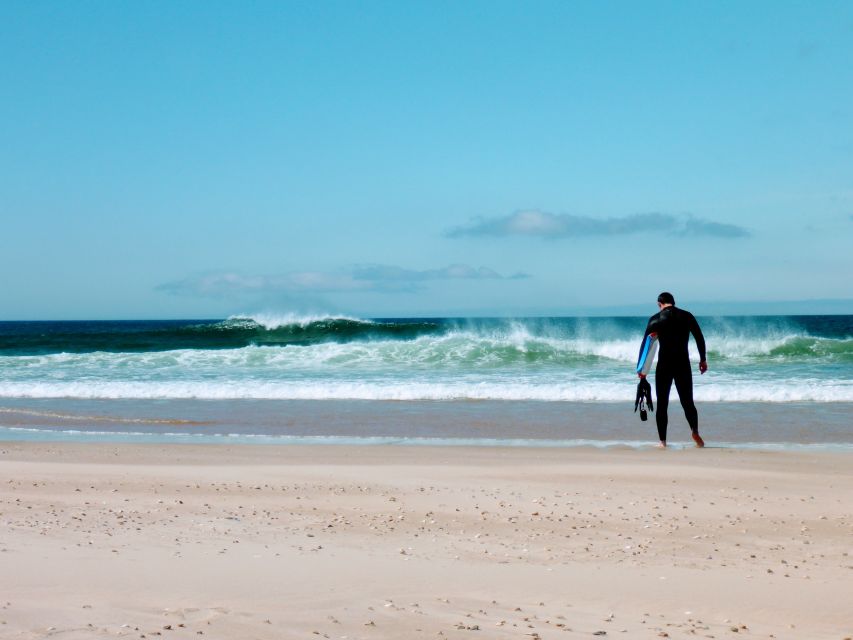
0 442 853 640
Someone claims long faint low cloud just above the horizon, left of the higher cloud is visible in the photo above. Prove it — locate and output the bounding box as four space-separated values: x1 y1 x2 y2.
156 264 530 298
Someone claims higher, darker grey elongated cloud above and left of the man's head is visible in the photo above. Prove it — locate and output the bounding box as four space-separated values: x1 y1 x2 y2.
444 209 752 238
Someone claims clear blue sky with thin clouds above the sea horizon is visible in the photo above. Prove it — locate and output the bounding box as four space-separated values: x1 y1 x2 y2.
0 1 853 319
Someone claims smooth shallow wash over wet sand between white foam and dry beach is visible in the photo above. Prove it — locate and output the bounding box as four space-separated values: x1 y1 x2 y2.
5 400 853 444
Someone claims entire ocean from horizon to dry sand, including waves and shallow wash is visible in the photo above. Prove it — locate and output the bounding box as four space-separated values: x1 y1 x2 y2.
0 315 853 449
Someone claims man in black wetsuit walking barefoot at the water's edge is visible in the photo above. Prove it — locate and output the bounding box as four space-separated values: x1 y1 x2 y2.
638 291 708 447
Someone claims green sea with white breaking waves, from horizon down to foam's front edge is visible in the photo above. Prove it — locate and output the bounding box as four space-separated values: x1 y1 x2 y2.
0 315 853 402
